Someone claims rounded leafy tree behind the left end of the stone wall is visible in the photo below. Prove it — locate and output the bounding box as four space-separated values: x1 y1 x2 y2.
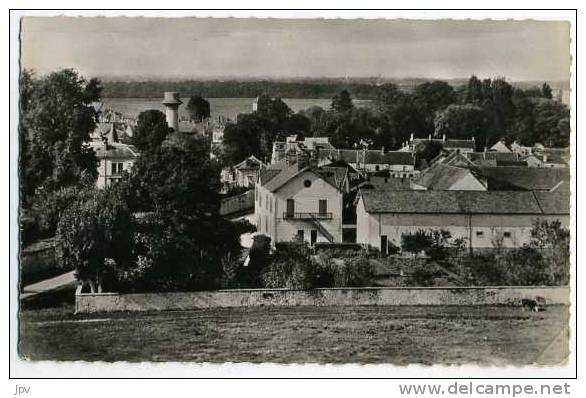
55 189 132 293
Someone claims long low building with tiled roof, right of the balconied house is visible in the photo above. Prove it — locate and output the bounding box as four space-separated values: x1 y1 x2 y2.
356 189 570 253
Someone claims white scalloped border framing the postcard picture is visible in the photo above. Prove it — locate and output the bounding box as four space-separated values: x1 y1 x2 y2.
1 6 586 380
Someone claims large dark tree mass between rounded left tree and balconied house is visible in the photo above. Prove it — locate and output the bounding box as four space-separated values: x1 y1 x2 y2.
119 139 242 290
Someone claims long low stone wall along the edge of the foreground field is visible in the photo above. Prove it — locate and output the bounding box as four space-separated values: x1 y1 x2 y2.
75 287 570 313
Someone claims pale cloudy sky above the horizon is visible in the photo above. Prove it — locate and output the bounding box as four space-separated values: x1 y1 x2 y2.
21 17 570 81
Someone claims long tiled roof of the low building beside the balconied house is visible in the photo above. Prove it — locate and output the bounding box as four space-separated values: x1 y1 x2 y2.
360 189 567 214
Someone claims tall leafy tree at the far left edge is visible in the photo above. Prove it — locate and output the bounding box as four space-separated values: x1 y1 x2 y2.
19 69 102 206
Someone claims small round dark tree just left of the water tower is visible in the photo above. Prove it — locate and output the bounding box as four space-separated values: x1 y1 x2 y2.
132 109 171 152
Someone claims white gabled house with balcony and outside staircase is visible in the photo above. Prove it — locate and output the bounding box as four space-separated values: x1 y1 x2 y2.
254 163 345 244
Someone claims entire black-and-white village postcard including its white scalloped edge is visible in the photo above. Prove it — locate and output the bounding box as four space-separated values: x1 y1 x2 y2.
10 11 576 382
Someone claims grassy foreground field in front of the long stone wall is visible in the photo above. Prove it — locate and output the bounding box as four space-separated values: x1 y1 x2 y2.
20 296 569 365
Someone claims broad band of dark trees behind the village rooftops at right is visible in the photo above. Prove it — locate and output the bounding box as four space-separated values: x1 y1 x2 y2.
220 76 570 165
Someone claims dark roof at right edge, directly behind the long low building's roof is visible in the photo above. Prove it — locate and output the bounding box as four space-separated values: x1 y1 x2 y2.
474 167 570 191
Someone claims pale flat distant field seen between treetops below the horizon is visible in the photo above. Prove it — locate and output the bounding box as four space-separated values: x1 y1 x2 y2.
102 97 371 120
